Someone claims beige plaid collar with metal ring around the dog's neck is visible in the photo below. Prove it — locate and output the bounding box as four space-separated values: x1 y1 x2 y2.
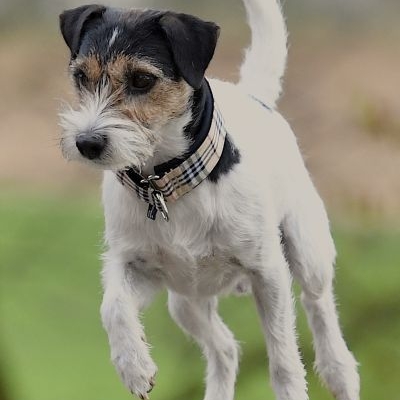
117 86 227 221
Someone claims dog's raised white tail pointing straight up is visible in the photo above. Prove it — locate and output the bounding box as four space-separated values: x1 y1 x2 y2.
239 0 287 108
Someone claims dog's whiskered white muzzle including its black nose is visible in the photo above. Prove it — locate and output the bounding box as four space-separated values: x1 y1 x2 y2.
60 98 156 170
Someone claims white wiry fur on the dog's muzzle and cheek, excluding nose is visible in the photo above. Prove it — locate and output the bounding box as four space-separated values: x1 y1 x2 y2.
60 84 191 172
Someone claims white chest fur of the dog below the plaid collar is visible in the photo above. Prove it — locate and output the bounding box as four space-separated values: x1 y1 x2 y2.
104 163 263 296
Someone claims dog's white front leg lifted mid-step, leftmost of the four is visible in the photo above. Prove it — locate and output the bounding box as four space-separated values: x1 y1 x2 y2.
101 252 161 399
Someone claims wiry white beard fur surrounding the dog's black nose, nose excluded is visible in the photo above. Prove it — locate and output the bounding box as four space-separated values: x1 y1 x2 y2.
59 85 155 170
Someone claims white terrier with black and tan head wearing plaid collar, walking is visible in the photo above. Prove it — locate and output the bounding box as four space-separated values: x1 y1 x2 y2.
60 0 359 400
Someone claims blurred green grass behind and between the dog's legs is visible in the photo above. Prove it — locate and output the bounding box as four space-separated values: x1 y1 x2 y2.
0 192 400 400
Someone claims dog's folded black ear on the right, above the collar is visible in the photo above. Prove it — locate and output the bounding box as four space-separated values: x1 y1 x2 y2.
160 12 220 89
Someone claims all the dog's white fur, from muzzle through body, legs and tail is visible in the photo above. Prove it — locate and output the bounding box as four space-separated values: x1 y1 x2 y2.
63 0 359 400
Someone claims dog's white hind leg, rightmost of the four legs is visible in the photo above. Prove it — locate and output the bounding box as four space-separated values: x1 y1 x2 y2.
283 194 359 400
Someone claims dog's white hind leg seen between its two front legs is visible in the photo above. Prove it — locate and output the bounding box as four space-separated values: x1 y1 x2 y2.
168 292 238 400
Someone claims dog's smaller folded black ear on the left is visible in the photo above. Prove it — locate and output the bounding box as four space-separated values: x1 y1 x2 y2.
60 4 106 58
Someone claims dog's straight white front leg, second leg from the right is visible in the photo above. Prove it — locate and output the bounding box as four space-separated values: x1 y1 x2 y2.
247 235 308 400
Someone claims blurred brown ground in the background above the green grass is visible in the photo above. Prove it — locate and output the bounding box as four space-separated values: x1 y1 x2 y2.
0 25 400 215
